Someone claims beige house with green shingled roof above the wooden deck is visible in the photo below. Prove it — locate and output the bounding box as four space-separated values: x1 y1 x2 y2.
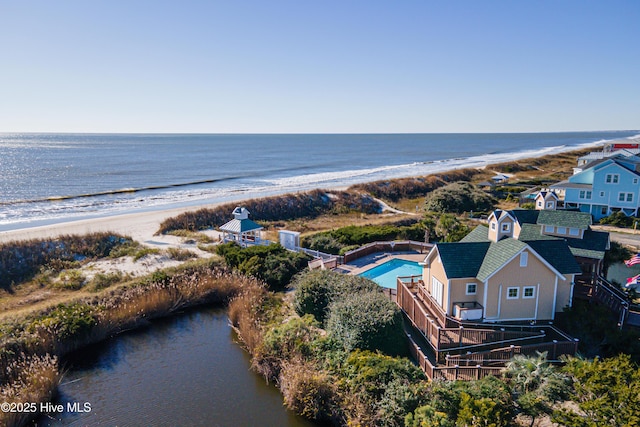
422 226 581 322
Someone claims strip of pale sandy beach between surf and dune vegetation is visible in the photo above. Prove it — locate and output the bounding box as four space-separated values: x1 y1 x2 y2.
0 143 600 245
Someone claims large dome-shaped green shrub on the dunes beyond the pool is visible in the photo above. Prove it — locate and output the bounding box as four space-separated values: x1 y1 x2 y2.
425 182 495 213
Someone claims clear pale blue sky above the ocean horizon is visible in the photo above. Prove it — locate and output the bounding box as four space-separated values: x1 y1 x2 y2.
0 0 640 133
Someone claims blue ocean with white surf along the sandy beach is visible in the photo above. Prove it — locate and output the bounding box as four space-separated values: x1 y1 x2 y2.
0 131 639 231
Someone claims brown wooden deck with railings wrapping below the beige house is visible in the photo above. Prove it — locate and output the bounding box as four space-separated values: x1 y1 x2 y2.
396 277 578 380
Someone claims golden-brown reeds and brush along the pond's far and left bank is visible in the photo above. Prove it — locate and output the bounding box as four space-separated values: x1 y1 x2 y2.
0 260 262 426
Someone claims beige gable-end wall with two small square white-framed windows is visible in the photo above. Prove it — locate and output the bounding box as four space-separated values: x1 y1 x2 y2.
485 250 556 320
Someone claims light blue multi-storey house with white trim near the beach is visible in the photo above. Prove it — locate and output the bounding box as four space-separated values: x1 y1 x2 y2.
551 153 640 220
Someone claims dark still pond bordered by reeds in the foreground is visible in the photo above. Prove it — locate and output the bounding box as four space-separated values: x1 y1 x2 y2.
37 308 314 427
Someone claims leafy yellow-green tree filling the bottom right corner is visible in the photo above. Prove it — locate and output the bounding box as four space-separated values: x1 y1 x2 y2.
552 354 640 427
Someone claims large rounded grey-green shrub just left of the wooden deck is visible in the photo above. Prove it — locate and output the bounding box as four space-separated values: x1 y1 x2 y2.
327 290 407 355
